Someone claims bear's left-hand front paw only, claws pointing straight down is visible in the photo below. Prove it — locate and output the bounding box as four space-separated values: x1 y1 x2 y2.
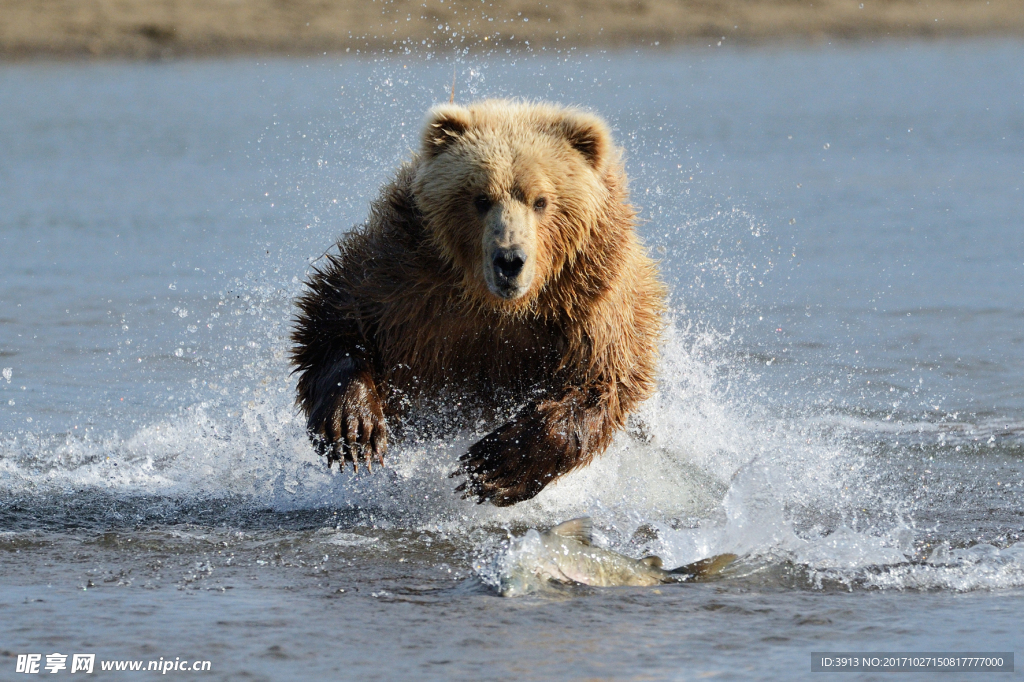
309 372 387 471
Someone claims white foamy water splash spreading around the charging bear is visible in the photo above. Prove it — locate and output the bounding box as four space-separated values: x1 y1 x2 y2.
9 288 1024 590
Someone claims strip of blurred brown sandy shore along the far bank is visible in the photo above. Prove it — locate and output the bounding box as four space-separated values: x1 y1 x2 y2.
6 0 1024 59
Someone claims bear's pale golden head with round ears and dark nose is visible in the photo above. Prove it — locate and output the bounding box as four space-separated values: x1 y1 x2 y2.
413 99 624 309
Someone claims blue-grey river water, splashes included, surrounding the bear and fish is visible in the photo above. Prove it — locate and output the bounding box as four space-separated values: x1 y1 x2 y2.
0 41 1024 680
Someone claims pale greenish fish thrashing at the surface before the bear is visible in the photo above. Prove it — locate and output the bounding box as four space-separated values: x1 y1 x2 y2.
499 516 737 596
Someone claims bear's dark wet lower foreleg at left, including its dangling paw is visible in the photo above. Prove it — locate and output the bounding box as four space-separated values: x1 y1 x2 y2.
298 357 387 471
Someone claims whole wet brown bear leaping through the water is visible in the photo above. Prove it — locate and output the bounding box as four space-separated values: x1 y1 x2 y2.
292 100 665 506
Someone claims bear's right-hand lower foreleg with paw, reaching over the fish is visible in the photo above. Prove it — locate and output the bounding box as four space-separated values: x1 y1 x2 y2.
452 392 623 507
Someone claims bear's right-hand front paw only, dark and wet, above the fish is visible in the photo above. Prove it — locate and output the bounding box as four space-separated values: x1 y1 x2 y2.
452 420 558 507
